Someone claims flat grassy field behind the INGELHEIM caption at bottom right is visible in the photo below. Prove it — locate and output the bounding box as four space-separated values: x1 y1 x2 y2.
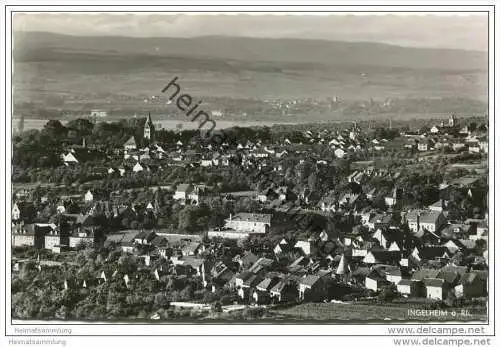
274 303 487 322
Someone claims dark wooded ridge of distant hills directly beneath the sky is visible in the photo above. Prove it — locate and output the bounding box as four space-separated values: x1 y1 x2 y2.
13 32 488 71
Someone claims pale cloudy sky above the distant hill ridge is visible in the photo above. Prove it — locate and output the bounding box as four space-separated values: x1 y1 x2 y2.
13 13 488 51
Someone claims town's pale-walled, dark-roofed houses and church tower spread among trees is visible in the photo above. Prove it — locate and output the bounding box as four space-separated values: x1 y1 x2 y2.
12 116 488 303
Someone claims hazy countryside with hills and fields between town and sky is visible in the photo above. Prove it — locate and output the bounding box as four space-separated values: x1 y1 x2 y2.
13 33 487 122
